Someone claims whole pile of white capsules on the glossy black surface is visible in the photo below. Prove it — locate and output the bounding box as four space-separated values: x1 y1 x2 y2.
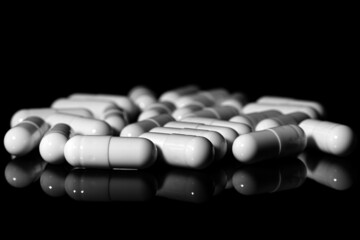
4 85 355 169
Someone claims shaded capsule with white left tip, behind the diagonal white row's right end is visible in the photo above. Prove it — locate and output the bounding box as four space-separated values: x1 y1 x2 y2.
229 110 282 129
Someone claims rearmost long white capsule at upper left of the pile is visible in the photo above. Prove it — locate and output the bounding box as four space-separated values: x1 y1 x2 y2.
69 93 139 121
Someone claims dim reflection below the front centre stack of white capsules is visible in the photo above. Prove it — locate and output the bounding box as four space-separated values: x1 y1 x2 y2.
156 169 217 203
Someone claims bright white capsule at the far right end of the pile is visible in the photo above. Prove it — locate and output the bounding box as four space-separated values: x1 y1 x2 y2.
299 119 356 156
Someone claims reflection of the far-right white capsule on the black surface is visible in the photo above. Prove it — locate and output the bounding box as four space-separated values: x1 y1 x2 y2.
299 151 358 191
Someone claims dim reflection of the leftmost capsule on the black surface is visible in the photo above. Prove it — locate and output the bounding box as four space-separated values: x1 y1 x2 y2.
4 152 47 188
